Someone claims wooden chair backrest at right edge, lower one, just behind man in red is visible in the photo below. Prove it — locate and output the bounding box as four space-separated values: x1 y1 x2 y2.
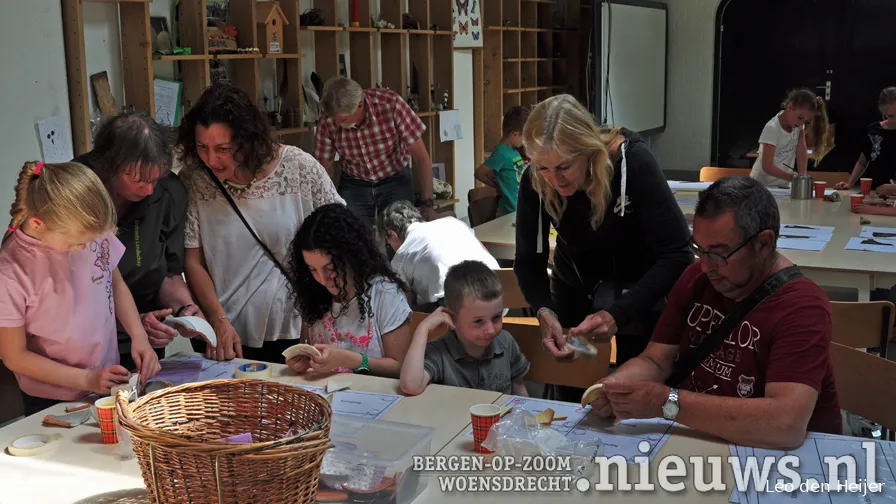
831 343 896 430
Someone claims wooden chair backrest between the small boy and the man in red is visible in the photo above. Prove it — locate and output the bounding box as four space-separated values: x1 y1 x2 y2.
504 322 611 388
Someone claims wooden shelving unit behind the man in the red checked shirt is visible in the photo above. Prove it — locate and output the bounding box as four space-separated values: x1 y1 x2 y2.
62 0 456 212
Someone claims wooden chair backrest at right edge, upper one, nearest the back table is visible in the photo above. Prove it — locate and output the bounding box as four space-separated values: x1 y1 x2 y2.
831 301 896 358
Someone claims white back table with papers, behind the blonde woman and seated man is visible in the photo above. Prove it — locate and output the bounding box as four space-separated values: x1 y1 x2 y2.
474 190 896 301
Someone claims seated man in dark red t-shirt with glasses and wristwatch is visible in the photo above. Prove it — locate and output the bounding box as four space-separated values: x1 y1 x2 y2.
592 177 842 449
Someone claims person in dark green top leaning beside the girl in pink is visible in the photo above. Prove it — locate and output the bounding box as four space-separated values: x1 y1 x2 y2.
74 114 202 370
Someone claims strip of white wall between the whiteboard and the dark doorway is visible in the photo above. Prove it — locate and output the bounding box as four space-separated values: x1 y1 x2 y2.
649 0 718 171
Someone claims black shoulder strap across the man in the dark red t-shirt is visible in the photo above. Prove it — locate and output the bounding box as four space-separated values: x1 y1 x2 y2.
666 266 803 388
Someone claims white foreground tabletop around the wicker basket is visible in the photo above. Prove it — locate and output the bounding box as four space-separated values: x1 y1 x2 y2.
0 354 501 504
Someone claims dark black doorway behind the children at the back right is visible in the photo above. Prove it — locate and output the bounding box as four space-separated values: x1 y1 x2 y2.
712 0 896 171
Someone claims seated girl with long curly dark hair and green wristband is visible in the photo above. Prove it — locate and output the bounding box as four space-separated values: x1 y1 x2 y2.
287 204 411 378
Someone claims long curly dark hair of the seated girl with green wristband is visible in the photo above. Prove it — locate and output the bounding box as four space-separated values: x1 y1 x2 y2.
287 203 408 325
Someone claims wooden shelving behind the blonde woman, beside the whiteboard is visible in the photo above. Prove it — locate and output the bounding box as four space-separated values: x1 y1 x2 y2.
473 0 587 165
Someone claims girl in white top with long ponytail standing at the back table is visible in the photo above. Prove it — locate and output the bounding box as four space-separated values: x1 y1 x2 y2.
750 89 828 187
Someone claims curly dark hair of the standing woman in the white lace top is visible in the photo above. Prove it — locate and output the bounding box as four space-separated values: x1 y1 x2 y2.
177 84 277 175
